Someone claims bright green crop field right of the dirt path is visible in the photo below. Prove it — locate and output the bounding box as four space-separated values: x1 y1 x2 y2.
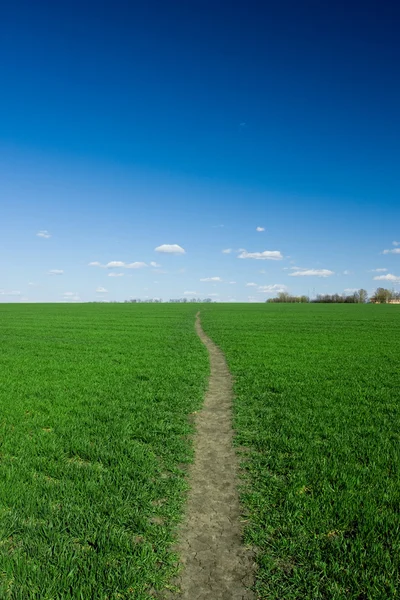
201 304 400 600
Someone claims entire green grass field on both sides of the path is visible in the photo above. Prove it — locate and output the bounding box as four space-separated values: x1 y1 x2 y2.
0 304 400 600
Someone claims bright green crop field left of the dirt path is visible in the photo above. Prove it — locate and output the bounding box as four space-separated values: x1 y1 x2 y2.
0 304 209 600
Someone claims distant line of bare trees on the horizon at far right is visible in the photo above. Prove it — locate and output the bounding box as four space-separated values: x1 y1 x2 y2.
266 288 400 304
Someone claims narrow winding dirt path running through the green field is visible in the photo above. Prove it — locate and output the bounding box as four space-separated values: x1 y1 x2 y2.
166 314 255 600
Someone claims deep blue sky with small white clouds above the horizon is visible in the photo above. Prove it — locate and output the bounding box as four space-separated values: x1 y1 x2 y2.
0 0 400 302
